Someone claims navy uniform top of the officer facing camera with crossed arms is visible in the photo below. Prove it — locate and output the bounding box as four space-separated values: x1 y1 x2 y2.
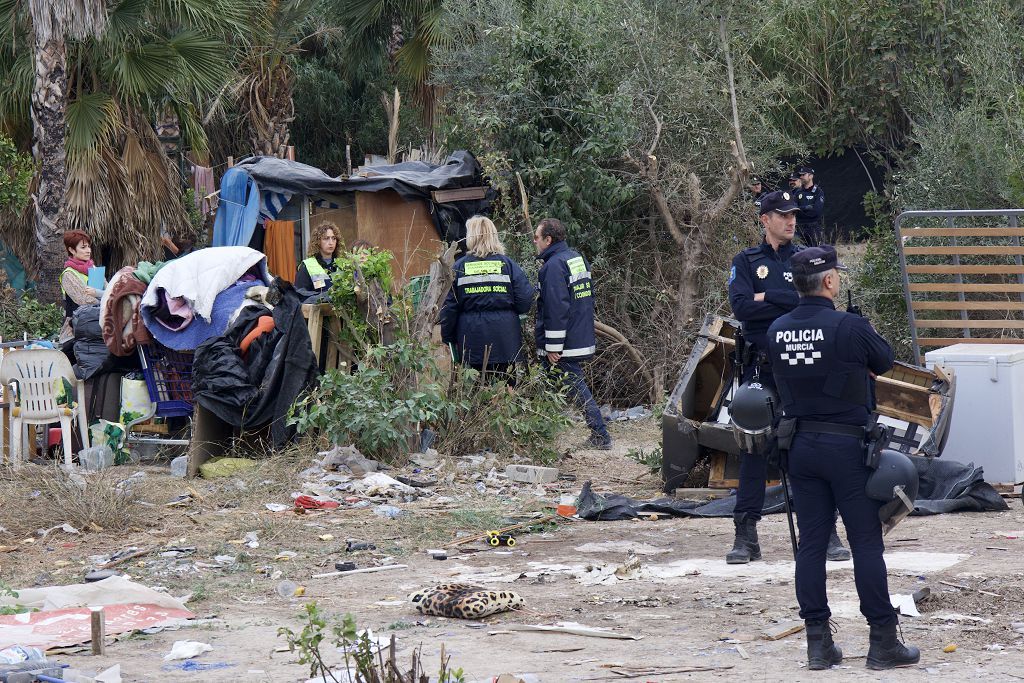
729 242 803 351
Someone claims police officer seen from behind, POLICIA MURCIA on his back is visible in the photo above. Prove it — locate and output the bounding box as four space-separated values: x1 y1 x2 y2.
768 246 921 670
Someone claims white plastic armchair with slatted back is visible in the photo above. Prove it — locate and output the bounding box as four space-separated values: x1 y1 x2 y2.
0 349 89 467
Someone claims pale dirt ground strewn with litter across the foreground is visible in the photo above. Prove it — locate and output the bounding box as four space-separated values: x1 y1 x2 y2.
0 420 1024 683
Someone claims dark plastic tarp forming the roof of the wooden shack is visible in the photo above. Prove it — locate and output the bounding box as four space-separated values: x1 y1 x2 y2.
236 151 498 242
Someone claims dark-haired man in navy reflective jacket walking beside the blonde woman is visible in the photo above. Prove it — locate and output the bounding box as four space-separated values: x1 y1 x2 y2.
534 218 611 451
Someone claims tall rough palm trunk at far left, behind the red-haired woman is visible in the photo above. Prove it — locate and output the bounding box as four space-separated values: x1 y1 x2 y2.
32 36 68 303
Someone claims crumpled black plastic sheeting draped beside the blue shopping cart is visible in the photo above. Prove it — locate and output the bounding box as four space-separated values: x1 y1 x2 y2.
193 279 317 447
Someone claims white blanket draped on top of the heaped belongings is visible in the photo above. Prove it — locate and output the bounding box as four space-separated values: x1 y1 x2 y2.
142 247 271 321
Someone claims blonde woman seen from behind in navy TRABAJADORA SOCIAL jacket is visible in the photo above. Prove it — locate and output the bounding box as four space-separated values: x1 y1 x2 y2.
440 216 534 380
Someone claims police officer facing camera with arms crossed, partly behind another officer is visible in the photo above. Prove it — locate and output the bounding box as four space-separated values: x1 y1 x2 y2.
725 190 850 564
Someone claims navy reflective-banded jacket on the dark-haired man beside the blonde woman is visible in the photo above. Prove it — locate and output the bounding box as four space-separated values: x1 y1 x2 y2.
535 241 597 360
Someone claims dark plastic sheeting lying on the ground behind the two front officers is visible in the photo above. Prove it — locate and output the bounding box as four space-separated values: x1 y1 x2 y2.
577 456 1008 521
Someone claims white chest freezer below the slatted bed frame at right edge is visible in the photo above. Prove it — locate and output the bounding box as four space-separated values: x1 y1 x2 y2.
925 343 1024 483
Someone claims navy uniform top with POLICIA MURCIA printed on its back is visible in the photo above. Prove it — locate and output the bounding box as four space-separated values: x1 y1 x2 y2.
768 296 893 426
